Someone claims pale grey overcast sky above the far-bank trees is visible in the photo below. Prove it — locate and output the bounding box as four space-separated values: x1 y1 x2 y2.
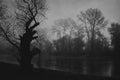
47 0 120 24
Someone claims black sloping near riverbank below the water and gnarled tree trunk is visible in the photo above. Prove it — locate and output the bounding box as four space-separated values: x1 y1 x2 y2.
0 62 120 80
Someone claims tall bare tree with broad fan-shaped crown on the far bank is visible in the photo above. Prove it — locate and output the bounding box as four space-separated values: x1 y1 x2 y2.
77 8 107 54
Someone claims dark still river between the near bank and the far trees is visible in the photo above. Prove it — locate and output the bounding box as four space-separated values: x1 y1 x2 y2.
0 55 120 77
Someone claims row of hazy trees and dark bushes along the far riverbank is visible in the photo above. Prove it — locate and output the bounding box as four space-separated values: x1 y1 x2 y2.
41 8 117 57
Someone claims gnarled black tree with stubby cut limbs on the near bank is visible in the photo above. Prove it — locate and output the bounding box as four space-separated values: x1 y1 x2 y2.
1 0 46 71
